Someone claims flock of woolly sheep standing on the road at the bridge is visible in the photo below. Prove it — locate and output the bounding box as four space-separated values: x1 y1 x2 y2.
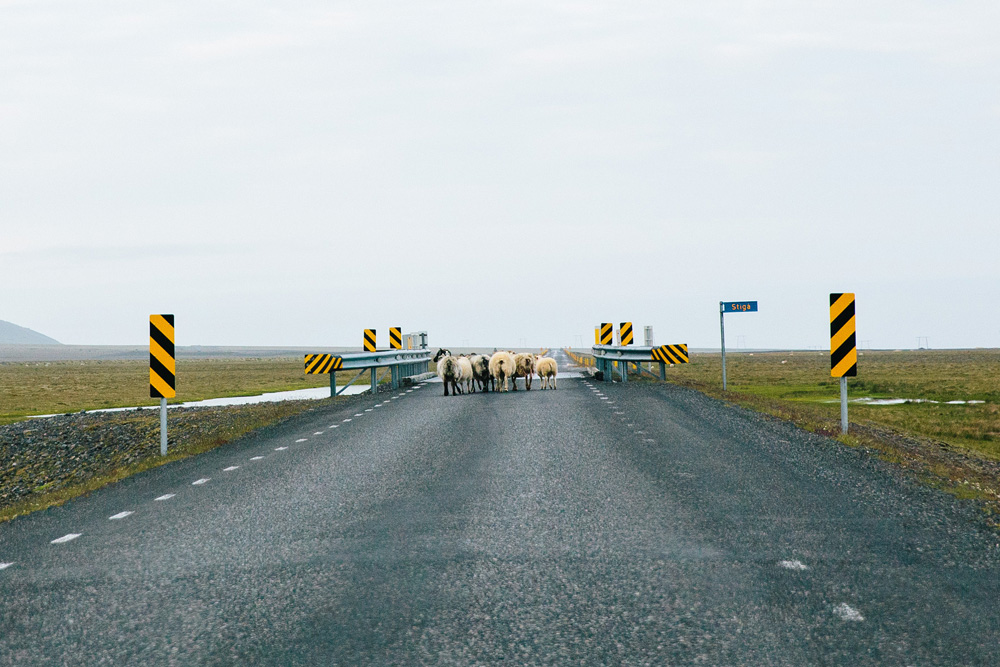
434 349 558 396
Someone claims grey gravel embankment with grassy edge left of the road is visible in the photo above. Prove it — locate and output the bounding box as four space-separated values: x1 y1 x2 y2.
0 397 352 510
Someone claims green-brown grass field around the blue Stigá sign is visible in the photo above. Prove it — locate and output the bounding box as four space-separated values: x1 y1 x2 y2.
616 349 1000 459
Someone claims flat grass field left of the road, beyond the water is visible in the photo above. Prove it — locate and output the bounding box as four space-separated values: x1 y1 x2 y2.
0 357 392 424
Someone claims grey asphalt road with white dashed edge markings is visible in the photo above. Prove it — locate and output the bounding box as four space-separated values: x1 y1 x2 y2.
0 358 1000 665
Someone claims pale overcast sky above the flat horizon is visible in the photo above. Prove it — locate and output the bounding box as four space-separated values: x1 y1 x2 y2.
0 0 1000 348
